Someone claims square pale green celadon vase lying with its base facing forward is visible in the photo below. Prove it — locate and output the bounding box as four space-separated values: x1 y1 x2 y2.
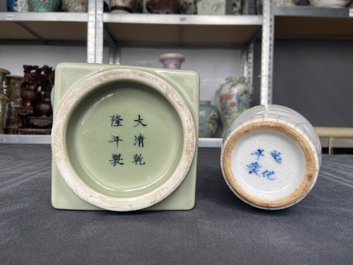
52 63 200 211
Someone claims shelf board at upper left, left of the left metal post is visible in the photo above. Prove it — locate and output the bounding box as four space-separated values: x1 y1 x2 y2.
0 12 88 44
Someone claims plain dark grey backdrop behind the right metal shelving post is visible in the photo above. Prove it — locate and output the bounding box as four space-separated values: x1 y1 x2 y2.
253 40 353 127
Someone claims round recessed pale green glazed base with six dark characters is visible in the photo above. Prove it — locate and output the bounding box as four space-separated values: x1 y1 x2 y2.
67 84 183 197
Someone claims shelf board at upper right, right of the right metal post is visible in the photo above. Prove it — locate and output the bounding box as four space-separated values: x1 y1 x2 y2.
273 6 353 40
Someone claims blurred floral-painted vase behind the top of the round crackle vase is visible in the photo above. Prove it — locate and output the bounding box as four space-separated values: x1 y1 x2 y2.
216 76 253 131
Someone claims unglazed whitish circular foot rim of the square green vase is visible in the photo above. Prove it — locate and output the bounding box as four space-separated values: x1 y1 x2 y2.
52 69 197 211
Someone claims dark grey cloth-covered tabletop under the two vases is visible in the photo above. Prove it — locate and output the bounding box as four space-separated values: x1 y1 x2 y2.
0 145 353 265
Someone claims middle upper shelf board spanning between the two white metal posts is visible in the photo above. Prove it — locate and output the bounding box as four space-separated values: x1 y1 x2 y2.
103 13 262 46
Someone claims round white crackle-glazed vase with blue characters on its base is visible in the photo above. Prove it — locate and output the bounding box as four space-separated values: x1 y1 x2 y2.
221 105 322 210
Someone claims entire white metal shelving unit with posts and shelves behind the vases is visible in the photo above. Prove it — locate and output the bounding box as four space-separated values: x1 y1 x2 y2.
0 0 353 147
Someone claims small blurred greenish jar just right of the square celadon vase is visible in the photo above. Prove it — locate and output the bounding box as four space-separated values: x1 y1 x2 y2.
199 101 219 137
